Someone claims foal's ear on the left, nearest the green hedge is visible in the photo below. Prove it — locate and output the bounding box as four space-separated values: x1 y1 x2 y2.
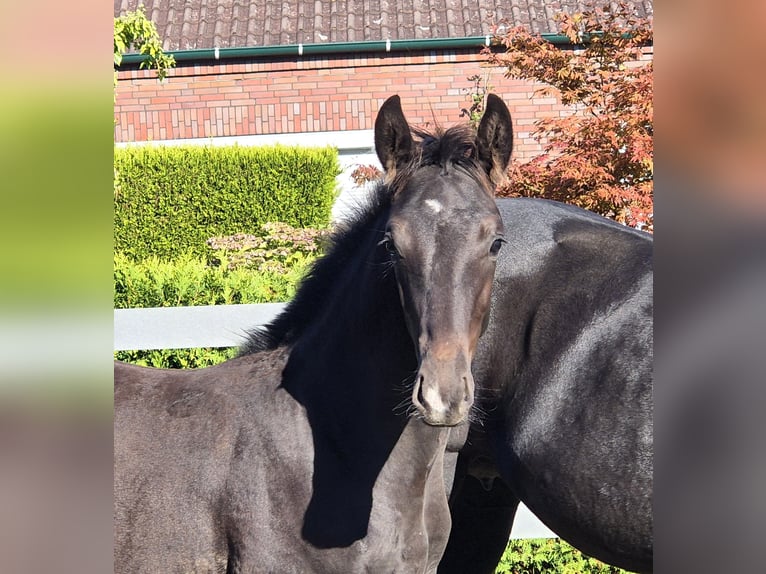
375 96 414 179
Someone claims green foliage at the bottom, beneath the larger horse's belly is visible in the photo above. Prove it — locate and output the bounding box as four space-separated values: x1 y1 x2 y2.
495 538 625 574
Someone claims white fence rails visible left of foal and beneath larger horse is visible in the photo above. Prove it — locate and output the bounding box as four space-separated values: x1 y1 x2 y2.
114 303 556 538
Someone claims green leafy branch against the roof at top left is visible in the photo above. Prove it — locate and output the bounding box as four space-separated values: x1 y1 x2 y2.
114 5 176 85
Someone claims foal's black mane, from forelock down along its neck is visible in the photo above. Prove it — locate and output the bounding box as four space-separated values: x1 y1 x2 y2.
239 124 487 355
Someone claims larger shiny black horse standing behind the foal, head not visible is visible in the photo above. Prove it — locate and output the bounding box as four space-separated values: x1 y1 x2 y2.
439 199 653 574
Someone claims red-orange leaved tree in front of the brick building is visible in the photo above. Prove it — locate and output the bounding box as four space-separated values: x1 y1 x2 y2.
484 2 654 230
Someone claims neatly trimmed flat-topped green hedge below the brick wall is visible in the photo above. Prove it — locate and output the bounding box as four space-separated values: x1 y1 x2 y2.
114 146 340 261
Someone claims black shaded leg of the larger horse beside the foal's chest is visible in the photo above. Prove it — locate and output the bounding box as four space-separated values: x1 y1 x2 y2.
438 453 519 574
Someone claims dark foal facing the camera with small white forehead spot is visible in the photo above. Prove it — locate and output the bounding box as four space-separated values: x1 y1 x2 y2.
114 92 512 573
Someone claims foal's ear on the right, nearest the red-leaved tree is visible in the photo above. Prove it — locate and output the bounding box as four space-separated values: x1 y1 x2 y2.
476 94 513 185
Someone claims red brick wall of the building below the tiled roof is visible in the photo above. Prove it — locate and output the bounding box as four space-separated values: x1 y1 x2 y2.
114 46 644 164
